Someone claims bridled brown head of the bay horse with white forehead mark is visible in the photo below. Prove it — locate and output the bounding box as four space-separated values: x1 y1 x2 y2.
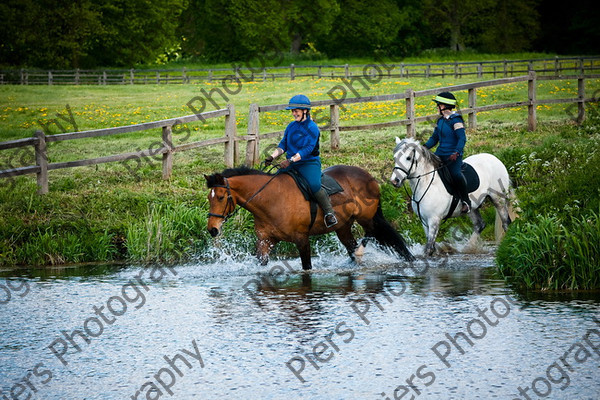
204 174 235 237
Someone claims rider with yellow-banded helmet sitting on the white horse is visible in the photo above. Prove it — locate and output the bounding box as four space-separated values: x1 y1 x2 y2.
425 92 471 214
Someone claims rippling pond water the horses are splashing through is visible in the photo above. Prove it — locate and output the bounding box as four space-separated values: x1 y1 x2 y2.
0 247 600 400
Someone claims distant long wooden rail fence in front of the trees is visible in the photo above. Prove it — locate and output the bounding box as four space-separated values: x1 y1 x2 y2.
0 56 600 85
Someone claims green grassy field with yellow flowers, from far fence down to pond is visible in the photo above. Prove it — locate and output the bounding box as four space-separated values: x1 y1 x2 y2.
0 69 600 276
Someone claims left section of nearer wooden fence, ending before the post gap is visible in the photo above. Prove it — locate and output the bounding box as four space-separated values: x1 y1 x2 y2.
0 104 243 194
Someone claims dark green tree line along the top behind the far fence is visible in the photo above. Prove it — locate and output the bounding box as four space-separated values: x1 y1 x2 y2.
0 0 600 69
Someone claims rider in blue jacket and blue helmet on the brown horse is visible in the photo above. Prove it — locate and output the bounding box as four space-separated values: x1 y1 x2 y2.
265 94 337 228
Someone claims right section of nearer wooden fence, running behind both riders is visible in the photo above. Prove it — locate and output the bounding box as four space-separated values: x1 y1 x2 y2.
246 72 600 165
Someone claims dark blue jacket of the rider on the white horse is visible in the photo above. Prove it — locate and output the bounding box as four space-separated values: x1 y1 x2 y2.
425 112 467 156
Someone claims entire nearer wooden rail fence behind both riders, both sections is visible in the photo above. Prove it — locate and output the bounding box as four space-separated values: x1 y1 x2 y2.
0 72 600 194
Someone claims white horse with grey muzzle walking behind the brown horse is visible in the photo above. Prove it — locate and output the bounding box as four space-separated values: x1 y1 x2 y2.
391 137 511 256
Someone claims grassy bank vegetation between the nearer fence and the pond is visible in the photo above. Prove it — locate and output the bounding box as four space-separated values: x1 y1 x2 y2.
0 84 600 289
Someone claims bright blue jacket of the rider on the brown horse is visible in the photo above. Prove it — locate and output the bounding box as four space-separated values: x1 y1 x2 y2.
277 116 321 162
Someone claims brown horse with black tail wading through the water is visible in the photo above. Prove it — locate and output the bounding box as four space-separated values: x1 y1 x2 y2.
204 165 413 270
